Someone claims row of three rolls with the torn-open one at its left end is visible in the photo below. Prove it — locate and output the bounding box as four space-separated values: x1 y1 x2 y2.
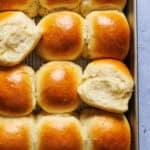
0 10 131 67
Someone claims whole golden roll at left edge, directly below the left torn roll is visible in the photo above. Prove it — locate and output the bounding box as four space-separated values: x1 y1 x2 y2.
0 65 36 117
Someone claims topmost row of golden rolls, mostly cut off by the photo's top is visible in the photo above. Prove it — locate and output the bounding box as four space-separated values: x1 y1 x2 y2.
0 0 127 17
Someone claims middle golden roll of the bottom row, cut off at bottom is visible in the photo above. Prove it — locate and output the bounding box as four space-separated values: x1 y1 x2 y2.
36 115 83 150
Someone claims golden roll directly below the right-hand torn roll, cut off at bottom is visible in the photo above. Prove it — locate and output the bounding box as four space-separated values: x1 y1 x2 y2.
81 110 131 150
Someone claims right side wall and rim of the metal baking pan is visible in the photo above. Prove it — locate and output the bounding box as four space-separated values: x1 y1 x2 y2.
125 0 139 150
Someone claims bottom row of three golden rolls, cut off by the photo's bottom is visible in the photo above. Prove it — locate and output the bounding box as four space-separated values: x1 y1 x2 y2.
0 109 131 150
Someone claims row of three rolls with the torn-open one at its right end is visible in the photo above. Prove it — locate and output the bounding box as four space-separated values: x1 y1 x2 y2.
0 59 134 117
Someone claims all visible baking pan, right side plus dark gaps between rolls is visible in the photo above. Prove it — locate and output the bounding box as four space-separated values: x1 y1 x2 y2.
25 0 139 150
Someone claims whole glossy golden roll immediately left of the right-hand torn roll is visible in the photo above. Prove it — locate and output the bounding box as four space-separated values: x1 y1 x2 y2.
36 61 82 113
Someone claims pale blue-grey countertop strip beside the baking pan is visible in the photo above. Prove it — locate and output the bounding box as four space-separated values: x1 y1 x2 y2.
138 0 150 150
